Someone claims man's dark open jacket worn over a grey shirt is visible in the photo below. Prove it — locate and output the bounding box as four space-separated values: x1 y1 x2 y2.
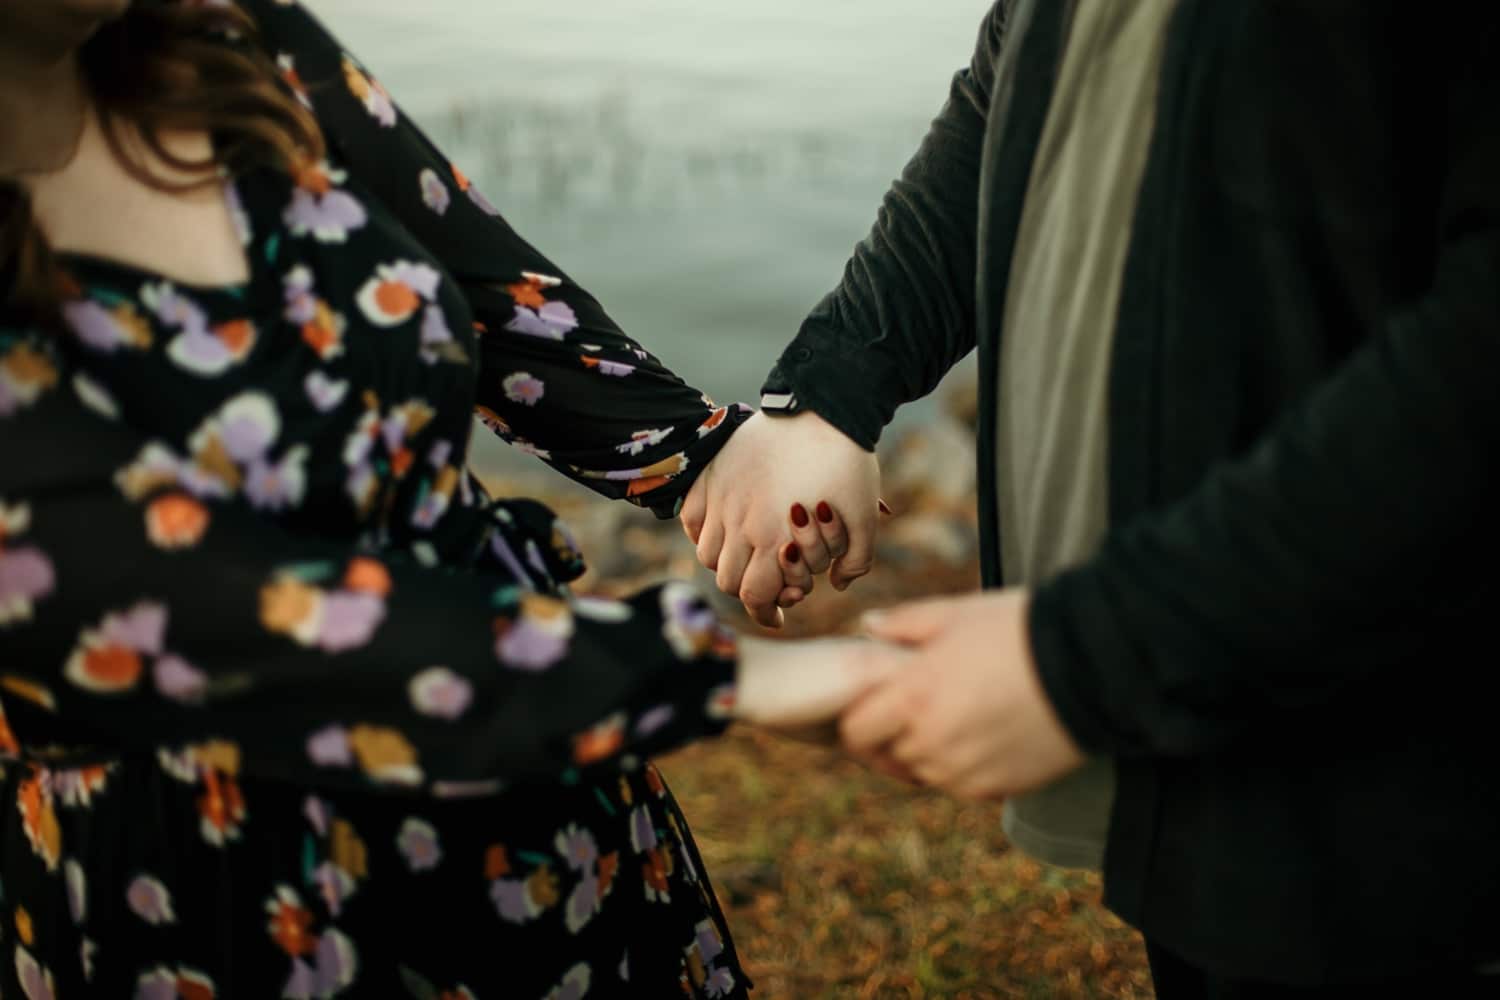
767 0 1500 984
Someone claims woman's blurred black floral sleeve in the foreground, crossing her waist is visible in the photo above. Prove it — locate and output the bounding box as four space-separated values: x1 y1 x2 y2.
0 328 734 795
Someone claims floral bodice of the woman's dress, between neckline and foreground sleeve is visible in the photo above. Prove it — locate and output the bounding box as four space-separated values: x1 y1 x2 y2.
65 165 476 531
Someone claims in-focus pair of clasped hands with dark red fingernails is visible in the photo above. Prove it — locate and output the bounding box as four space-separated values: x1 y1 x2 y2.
681 412 881 628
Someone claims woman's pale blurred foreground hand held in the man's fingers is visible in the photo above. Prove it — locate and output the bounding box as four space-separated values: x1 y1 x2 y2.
735 637 912 735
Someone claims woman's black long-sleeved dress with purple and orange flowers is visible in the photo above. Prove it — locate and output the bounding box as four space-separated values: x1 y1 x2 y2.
0 0 749 1000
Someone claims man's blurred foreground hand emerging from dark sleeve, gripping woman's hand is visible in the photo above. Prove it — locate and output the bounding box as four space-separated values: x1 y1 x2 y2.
842 591 1085 799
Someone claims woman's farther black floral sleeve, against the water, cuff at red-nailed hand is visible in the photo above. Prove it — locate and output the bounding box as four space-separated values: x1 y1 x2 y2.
246 0 750 517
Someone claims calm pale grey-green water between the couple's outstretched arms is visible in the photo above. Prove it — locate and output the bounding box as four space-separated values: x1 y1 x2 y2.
311 0 990 476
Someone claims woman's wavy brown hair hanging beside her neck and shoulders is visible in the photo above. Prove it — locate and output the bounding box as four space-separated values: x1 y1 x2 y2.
0 0 324 327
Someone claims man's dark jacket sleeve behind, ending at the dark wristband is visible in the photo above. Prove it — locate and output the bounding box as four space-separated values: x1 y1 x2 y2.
762 0 1013 450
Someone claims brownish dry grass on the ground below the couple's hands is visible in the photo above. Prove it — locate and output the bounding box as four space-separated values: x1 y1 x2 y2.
660 730 1152 1000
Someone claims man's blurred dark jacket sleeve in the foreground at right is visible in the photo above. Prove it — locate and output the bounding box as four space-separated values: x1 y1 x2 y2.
1031 7 1500 754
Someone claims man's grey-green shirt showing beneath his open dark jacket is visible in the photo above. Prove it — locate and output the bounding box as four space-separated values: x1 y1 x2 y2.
998 0 1176 868
